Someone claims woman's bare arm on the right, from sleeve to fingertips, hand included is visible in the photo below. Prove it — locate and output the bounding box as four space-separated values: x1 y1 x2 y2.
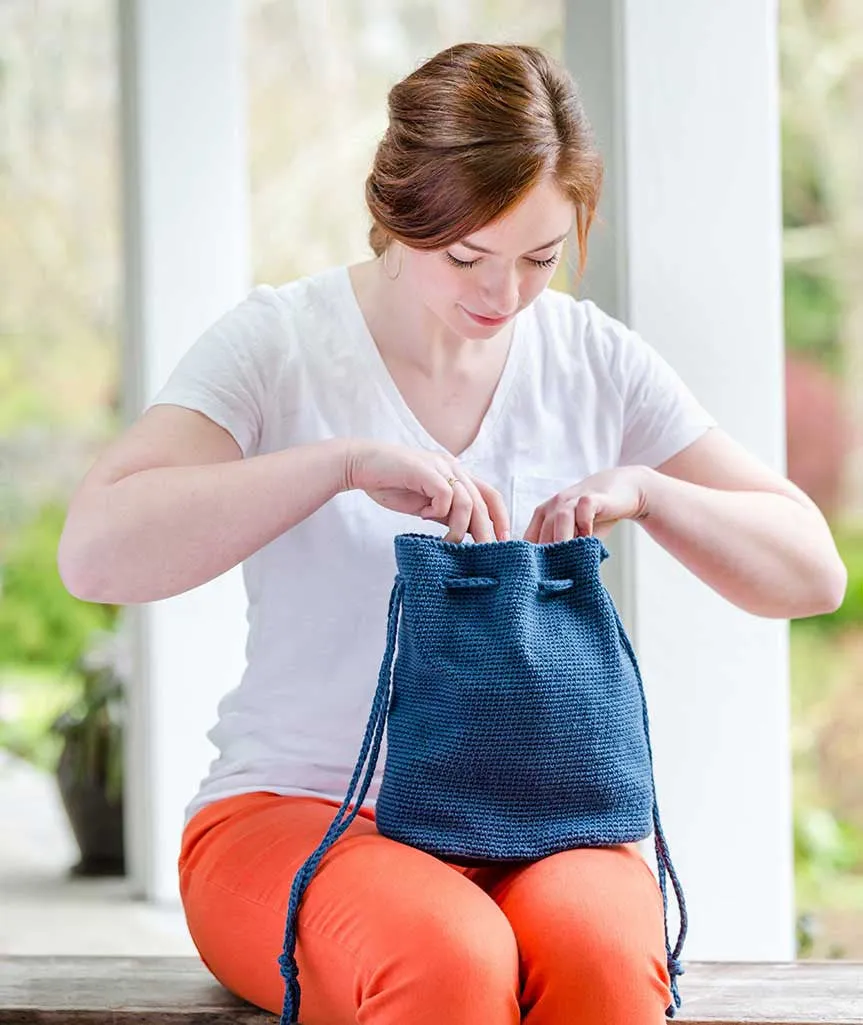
525 427 848 619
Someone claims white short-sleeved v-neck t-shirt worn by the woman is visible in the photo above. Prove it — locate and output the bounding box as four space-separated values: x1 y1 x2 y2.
147 267 715 821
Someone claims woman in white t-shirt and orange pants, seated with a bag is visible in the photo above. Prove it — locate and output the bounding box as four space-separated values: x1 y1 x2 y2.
58 44 846 1025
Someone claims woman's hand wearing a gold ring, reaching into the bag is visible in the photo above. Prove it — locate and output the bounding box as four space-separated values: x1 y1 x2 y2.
345 440 509 542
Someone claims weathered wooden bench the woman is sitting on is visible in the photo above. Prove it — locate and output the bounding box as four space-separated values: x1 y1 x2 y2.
0 957 863 1025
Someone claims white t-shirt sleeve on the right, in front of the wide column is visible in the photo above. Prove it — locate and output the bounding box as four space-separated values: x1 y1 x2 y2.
590 299 716 466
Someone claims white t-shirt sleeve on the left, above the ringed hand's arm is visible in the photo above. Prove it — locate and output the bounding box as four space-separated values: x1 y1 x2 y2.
144 285 286 457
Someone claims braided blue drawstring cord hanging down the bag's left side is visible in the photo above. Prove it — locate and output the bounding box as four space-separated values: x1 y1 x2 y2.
279 576 405 1025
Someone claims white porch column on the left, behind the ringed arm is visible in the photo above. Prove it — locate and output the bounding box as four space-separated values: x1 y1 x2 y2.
117 0 249 902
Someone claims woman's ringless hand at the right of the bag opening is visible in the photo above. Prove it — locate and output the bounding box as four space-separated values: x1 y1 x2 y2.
525 466 649 544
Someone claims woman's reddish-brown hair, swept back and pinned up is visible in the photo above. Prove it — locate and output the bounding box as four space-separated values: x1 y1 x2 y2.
366 43 603 274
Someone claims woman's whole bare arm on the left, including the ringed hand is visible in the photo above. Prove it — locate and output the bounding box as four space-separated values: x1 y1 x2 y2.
57 405 509 605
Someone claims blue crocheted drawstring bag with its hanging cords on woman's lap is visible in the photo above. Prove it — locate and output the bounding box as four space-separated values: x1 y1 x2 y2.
279 534 687 1025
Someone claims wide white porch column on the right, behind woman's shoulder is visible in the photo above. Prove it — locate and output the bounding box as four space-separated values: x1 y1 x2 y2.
566 0 794 960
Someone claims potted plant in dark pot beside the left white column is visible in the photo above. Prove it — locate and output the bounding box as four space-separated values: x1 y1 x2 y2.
52 628 130 875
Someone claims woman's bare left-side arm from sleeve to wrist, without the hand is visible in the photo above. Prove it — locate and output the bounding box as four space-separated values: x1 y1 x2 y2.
57 406 347 605
